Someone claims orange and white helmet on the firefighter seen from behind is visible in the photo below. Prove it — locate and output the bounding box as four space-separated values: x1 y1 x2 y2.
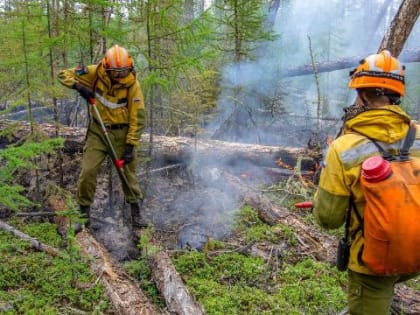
349 50 405 96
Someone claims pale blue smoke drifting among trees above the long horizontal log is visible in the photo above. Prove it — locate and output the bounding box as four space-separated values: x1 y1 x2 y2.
209 0 420 146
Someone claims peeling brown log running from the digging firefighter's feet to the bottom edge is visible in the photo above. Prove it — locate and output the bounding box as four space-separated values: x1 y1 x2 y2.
76 231 163 315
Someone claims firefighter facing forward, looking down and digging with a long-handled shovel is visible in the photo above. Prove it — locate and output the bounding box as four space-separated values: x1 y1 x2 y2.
58 45 145 227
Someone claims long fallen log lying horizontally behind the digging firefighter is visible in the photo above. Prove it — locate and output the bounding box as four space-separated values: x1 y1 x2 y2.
0 120 315 170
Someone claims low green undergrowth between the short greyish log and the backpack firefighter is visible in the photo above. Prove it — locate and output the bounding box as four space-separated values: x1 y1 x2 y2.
167 207 346 314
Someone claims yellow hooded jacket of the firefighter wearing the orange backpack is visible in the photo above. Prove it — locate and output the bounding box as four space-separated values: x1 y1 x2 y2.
314 105 420 274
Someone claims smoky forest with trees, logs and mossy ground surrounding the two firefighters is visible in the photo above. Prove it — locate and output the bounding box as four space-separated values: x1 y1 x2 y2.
0 0 420 315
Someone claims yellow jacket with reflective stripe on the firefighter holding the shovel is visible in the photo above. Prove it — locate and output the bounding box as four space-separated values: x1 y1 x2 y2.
58 64 146 146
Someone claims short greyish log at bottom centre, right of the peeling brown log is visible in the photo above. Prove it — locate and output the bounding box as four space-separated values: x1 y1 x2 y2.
151 251 205 315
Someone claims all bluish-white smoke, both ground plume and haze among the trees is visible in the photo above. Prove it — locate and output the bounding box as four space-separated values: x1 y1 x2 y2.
174 0 420 252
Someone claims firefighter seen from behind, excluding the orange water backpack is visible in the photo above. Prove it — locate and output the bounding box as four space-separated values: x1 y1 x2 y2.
314 50 420 315
